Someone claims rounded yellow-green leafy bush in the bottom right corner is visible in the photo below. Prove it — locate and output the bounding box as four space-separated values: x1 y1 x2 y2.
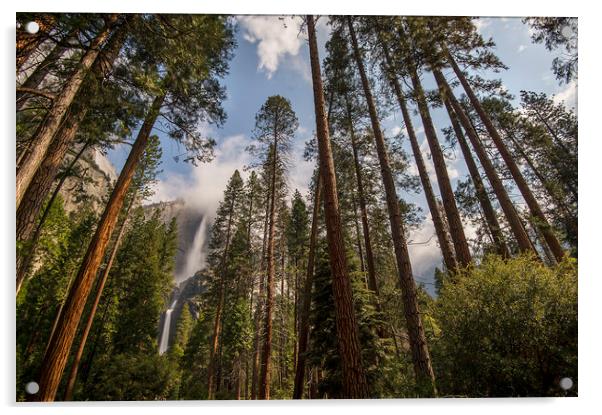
431 256 577 397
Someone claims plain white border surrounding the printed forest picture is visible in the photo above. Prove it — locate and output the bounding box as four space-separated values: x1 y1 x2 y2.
0 0 602 415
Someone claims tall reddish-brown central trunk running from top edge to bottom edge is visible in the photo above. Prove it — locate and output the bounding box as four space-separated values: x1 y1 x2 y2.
307 15 369 398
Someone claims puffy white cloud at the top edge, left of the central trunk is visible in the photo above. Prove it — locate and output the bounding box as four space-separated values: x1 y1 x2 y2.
237 16 304 78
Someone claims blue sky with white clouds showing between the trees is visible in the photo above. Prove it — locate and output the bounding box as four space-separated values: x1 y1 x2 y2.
109 16 577 292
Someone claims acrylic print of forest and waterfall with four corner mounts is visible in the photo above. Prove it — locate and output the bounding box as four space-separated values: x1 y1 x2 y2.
16 13 578 401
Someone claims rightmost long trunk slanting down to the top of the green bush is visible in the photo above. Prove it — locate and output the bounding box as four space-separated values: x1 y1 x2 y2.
445 49 565 262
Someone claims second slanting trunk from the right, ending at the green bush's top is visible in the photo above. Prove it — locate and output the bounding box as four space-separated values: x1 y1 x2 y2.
433 71 537 255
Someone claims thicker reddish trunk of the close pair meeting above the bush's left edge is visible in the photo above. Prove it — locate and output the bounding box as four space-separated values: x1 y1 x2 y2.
410 62 471 267
